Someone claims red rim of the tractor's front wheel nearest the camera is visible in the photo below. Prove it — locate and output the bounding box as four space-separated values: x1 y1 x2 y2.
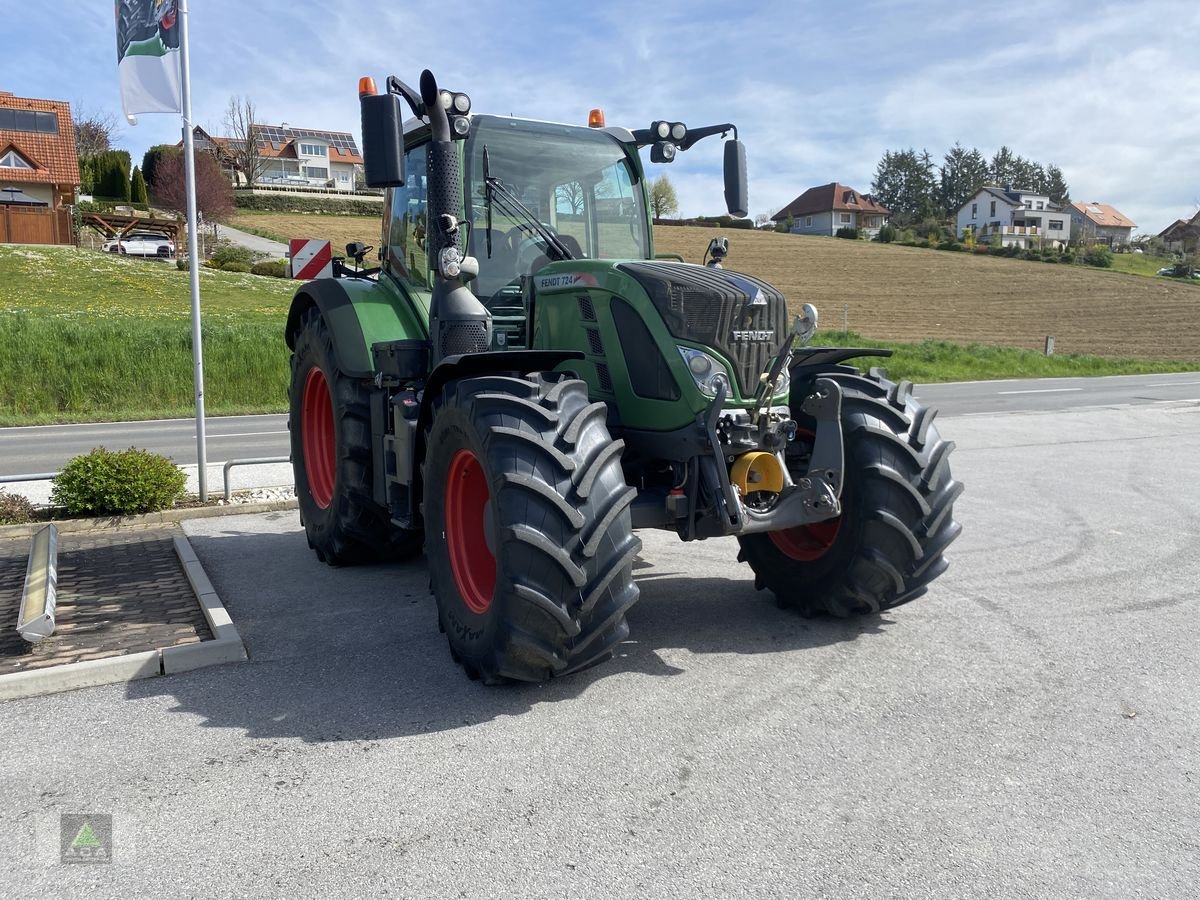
446 450 496 613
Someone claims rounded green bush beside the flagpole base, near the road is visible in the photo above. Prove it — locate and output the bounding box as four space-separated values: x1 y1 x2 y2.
50 446 187 516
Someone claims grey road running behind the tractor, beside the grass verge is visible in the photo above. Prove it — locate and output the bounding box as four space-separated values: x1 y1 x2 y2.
0 372 1200 475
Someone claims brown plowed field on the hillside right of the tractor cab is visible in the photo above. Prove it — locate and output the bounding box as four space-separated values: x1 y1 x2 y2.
654 226 1200 360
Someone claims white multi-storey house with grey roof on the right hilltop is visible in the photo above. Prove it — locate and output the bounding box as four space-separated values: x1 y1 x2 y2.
955 185 1070 247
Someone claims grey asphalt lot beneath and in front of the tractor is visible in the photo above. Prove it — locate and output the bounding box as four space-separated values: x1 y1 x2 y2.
0 405 1200 900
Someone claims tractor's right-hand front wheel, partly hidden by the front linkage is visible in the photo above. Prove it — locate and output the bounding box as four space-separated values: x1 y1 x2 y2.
738 371 962 616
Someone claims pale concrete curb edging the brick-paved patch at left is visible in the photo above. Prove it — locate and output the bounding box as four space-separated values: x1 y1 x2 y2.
0 535 248 701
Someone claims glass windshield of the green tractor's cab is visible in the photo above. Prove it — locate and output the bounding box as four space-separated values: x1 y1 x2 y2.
467 115 649 302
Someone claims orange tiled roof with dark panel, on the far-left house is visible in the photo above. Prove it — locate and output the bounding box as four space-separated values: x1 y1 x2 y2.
0 91 79 186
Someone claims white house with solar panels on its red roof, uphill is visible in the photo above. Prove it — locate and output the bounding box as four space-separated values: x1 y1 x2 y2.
176 122 362 191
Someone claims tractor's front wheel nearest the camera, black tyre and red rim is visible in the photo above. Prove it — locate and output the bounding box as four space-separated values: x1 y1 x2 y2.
424 374 642 683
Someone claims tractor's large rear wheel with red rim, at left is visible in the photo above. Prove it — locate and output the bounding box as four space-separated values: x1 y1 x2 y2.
288 307 421 565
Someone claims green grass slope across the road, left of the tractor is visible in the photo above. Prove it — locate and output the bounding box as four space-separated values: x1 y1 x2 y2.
0 245 295 425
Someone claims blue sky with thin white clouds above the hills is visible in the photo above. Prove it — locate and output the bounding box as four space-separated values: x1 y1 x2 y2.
0 0 1200 234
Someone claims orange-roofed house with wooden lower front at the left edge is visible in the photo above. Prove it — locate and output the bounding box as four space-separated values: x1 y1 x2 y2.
0 91 79 244
